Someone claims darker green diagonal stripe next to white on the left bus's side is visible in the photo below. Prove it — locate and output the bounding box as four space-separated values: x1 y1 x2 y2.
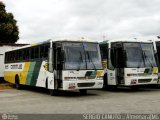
30 61 42 86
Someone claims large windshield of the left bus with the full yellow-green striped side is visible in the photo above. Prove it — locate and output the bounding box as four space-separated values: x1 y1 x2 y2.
63 43 102 70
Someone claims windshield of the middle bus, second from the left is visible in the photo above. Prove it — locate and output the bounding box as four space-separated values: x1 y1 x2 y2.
124 43 157 68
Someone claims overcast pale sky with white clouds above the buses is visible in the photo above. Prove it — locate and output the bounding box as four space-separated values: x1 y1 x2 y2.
2 0 160 43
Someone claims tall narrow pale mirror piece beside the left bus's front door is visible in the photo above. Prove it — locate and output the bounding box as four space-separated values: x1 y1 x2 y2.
48 48 53 72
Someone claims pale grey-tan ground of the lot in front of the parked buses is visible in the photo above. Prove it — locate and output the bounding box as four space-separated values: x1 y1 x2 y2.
0 84 160 114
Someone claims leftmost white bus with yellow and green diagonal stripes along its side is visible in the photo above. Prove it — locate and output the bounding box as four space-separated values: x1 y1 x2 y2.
4 38 103 95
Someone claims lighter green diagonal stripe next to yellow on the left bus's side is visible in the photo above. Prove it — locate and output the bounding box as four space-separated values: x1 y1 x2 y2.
26 62 36 85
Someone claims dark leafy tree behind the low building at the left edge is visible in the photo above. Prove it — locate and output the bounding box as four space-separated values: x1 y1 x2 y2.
0 2 19 43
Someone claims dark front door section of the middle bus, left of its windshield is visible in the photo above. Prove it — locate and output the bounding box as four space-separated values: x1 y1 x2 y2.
108 43 125 85
